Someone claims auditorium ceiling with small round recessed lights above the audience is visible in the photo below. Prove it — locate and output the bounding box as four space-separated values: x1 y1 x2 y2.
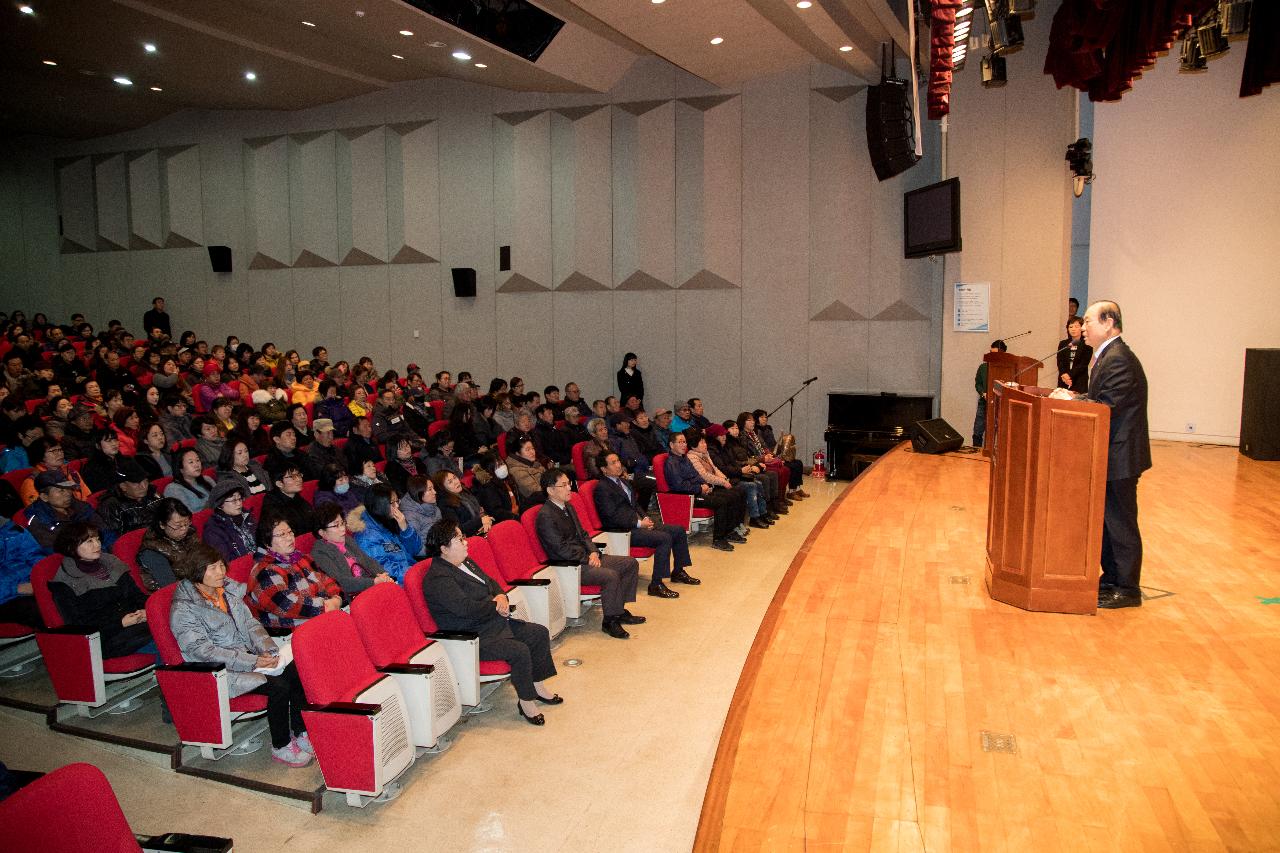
0 0 906 138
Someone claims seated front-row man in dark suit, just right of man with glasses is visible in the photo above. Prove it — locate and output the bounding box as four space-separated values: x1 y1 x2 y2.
595 452 703 598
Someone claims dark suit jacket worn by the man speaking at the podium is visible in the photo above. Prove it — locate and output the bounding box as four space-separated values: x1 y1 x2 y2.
1089 338 1151 480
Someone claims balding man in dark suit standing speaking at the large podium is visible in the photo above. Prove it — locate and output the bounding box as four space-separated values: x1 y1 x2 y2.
1084 301 1151 610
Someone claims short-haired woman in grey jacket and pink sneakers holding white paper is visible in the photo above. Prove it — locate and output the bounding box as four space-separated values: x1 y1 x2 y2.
169 543 315 767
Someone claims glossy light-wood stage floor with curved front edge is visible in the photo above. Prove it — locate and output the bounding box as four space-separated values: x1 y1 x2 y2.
695 442 1280 853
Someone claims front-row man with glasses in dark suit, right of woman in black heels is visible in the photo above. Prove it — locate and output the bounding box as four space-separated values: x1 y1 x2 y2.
538 467 645 639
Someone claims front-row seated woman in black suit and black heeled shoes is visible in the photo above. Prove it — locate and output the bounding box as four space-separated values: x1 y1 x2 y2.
422 519 563 726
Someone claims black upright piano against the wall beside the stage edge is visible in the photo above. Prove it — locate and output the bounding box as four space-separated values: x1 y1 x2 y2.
823 391 933 480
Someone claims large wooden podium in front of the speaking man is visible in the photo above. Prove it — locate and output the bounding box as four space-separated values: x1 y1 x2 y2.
987 384 1111 613
